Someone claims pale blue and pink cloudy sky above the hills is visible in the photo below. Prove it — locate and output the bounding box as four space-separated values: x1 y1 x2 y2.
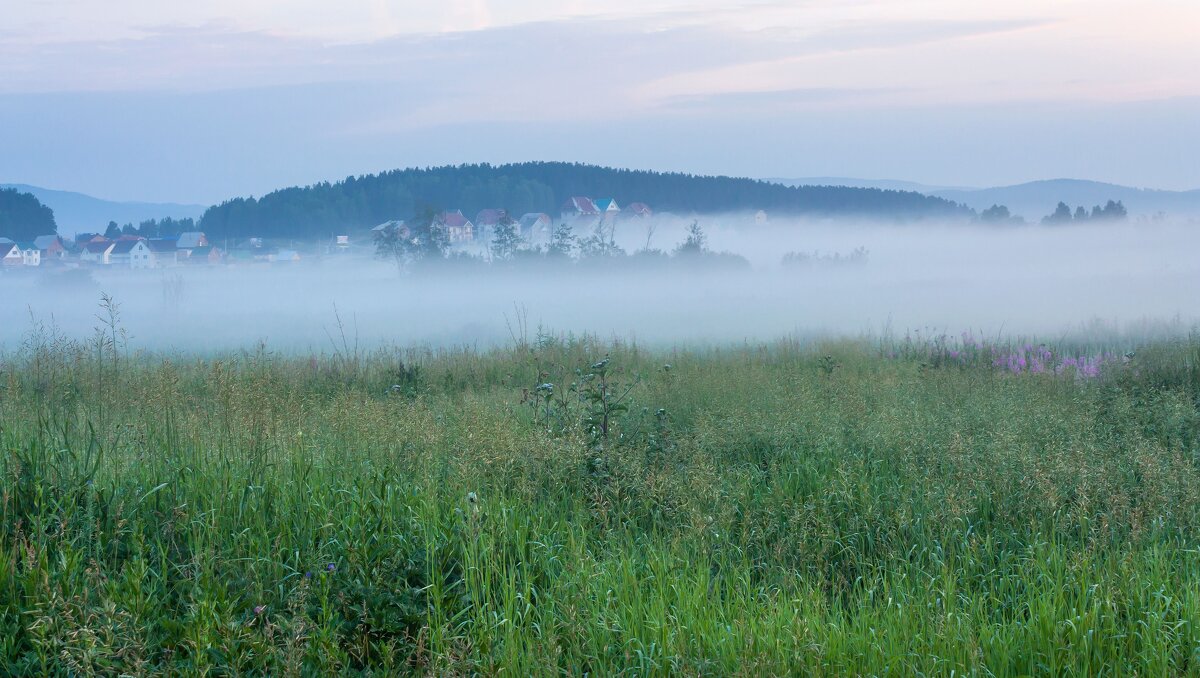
0 0 1200 204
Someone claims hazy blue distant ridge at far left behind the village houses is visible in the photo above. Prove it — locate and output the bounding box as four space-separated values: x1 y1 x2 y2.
0 184 206 236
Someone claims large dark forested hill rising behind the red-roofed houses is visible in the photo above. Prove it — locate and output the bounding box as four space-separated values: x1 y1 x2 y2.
200 162 967 238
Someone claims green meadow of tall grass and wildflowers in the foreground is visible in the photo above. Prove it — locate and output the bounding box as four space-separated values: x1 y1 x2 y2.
0 312 1200 676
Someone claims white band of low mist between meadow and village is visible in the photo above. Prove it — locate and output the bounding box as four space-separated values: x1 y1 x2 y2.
0 216 1200 353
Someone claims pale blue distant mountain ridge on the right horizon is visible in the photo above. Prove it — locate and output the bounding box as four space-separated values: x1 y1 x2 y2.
772 176 1200 222
